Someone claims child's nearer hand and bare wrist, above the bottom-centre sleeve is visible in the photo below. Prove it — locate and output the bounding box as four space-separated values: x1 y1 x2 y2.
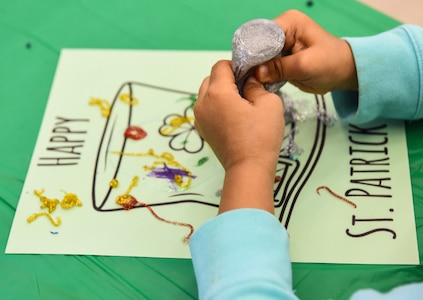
194 61 285 213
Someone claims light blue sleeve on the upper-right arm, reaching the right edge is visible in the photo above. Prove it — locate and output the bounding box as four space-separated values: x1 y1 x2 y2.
332 25 423 124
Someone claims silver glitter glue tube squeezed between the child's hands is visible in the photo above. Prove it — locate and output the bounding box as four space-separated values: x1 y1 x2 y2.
232 19 286 96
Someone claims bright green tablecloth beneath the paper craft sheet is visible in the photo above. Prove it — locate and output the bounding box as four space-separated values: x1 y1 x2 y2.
0 0 423 299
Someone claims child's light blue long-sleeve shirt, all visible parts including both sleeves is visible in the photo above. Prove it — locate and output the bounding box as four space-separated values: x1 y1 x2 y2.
190 25 423 300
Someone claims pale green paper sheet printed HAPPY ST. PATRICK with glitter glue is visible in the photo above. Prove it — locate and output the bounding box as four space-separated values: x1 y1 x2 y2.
6 49 419 264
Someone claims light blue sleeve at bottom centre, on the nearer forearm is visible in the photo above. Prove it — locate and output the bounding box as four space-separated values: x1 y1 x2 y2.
190 208 296 299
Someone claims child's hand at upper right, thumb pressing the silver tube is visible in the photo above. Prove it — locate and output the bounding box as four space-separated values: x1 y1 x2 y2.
256 10 358 94
